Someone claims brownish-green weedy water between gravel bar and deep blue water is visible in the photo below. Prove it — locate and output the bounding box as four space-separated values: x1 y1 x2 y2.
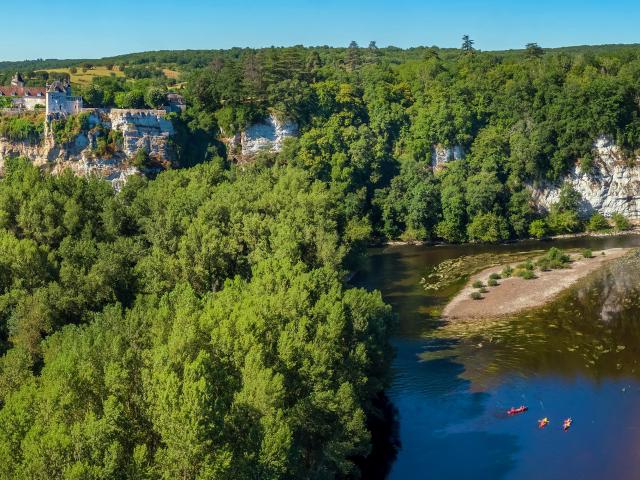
423 250 640 380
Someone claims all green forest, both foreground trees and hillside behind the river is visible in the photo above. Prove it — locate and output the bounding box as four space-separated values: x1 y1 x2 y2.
0 38 640 479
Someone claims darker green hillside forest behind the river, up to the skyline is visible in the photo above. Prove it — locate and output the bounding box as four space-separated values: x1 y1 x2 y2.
7 38 640 242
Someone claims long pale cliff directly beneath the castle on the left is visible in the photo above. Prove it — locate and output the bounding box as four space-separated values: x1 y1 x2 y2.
0 109 174 189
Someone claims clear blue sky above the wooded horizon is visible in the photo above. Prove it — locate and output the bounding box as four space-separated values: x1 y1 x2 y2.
0 0 640 61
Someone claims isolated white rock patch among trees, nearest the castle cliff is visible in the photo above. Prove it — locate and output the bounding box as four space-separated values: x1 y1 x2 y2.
227 114 298 157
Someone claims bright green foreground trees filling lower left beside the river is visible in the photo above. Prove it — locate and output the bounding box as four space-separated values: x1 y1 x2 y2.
0 159 392 479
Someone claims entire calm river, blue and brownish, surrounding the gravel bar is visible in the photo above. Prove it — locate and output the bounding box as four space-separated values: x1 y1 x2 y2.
354 236 640 479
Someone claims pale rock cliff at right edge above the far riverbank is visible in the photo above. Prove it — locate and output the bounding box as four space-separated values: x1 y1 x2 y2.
533 136 640 219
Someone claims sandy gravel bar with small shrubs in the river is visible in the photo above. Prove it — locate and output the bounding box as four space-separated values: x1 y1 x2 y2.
442 248 630 320
